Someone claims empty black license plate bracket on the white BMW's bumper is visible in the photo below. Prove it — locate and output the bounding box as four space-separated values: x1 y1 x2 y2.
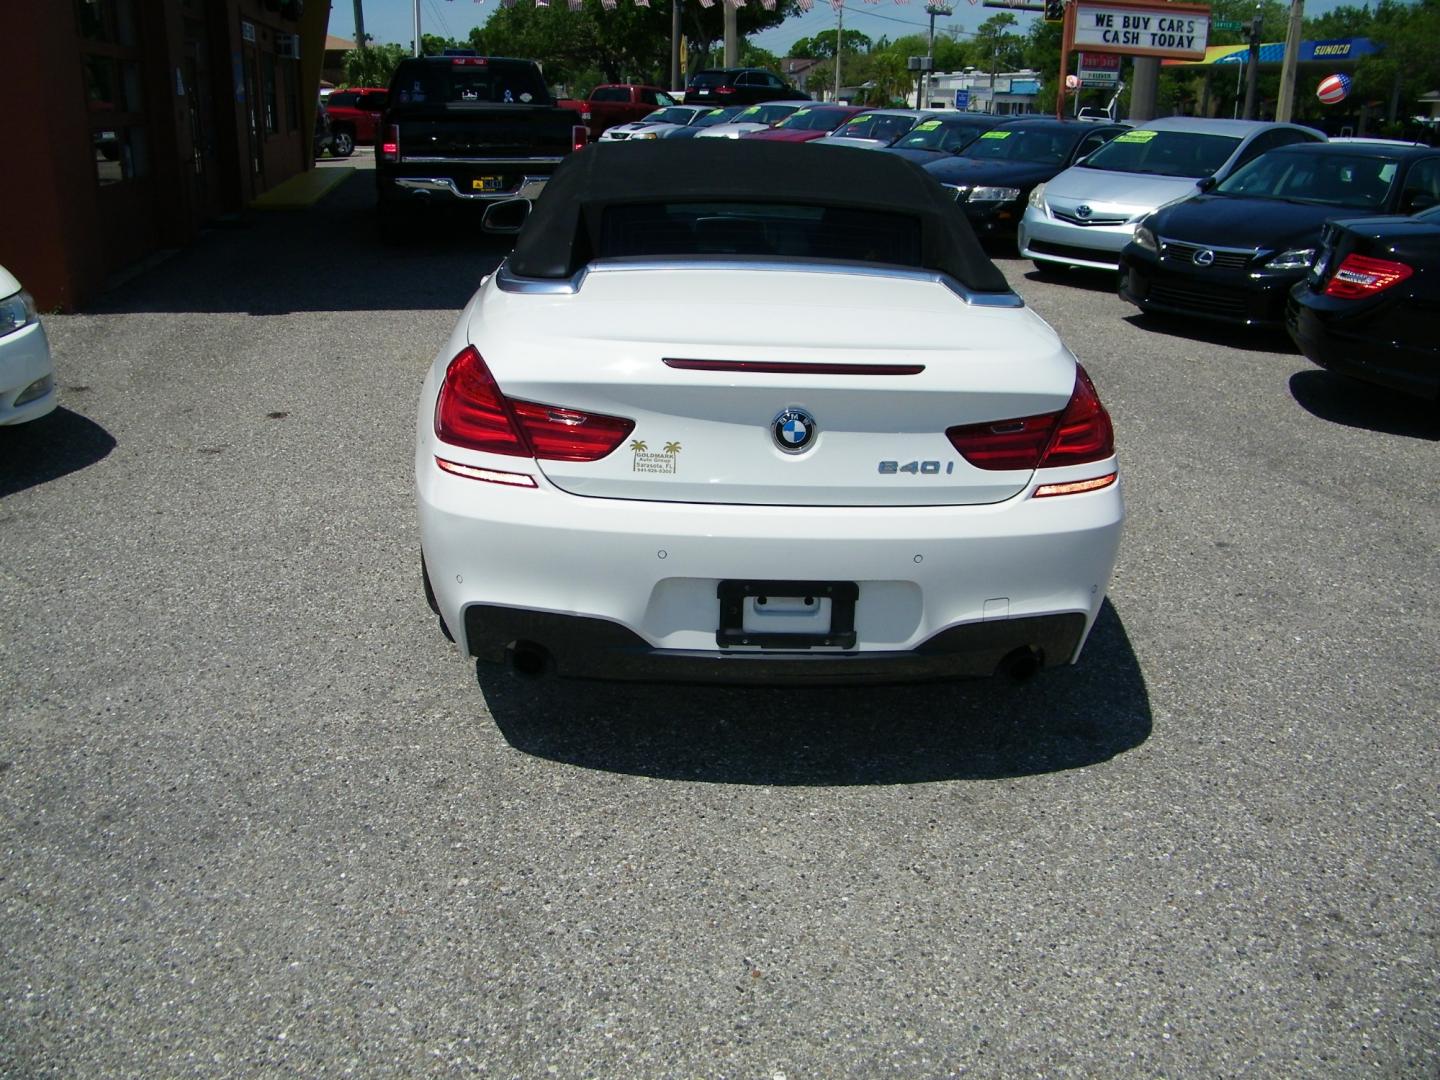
716 579 860 649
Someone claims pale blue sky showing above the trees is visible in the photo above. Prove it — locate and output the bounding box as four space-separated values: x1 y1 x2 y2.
330 0 1364 59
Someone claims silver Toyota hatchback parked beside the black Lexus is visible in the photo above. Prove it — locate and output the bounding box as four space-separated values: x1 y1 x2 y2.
1018 117 1325 271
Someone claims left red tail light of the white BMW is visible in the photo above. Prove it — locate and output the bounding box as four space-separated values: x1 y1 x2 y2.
435 346 635 461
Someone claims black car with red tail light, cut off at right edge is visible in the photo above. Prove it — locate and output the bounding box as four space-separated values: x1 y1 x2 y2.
1286 206 1440 402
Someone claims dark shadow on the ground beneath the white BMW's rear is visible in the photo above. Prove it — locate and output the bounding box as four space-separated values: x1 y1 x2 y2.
480 600 1152 786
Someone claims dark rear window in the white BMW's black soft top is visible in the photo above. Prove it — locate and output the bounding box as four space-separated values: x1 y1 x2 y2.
599 203 922 266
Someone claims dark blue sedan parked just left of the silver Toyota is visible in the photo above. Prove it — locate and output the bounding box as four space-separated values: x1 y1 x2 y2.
921 118 1128 240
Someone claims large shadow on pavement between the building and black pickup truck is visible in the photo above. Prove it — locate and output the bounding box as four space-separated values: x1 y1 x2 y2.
85 170 514 315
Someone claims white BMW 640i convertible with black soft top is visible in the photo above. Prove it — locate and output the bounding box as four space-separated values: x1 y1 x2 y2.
415 140 1125 684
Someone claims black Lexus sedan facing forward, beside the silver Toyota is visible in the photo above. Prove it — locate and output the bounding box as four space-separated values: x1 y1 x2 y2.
1120 141 1440 327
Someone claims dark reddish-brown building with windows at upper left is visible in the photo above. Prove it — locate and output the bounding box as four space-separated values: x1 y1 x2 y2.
0 0 330 310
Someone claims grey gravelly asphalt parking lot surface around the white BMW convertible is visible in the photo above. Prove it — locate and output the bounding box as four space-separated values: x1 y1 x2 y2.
0 161 1440 1080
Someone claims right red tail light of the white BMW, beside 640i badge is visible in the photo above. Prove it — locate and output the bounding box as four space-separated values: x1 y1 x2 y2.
945 364 1115 469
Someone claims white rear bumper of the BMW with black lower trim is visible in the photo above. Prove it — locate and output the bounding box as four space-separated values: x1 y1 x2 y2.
416 452 1125 683
